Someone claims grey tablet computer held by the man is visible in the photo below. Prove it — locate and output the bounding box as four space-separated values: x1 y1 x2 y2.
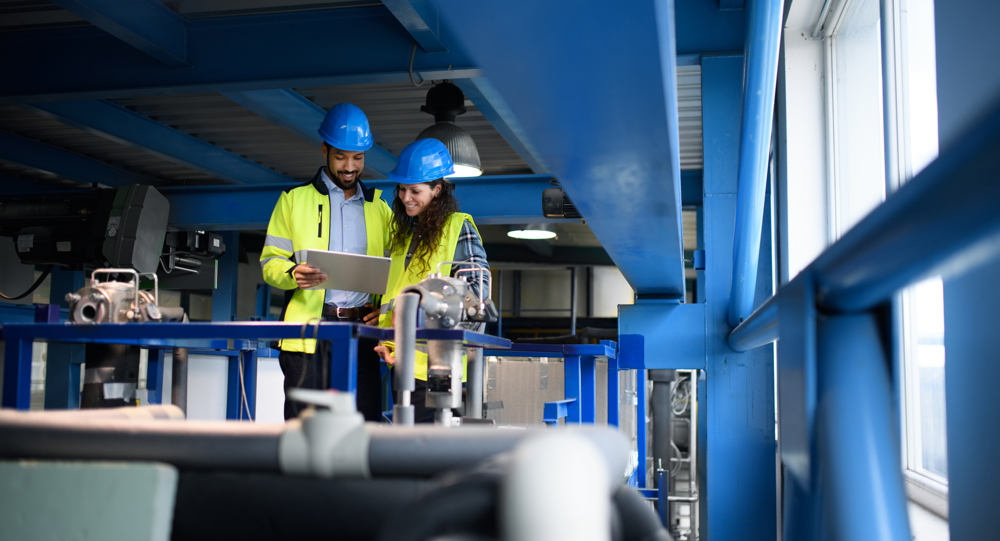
303 250 392 295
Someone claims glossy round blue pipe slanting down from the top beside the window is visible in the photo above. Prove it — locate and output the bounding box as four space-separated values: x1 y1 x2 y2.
729 0 784 327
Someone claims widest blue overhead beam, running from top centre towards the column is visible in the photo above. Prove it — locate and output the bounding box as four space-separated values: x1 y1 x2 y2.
437 0 688 298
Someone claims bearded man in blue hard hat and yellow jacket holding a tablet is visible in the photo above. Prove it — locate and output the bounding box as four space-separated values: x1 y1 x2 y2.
260 103 392 421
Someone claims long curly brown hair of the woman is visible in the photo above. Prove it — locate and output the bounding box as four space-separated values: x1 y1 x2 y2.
389 179 459 275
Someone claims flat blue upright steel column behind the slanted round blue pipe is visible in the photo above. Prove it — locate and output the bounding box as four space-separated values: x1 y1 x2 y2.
698 55 777 540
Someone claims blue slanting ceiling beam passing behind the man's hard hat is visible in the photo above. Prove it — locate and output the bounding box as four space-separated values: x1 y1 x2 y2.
223 88 396 178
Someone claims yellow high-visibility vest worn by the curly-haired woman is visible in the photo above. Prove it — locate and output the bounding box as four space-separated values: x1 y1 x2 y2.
378 212 482 381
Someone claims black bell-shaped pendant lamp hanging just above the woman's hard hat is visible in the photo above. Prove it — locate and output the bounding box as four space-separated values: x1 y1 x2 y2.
417 81 483 178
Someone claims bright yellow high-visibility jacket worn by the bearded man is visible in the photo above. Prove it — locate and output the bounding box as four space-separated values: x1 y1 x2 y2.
260 172 392 353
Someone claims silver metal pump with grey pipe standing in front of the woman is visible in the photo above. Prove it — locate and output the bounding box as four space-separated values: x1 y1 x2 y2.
393 261 497 426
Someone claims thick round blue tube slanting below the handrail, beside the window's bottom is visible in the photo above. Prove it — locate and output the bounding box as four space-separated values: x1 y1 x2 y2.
814 313 912 541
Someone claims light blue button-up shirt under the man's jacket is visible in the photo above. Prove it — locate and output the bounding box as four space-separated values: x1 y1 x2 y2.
322 169 369 308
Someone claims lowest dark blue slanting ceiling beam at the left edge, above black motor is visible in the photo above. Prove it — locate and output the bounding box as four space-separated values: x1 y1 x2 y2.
0 131 157 187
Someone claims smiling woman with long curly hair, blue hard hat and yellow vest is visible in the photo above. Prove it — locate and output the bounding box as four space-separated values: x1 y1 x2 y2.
375 139 490 423
